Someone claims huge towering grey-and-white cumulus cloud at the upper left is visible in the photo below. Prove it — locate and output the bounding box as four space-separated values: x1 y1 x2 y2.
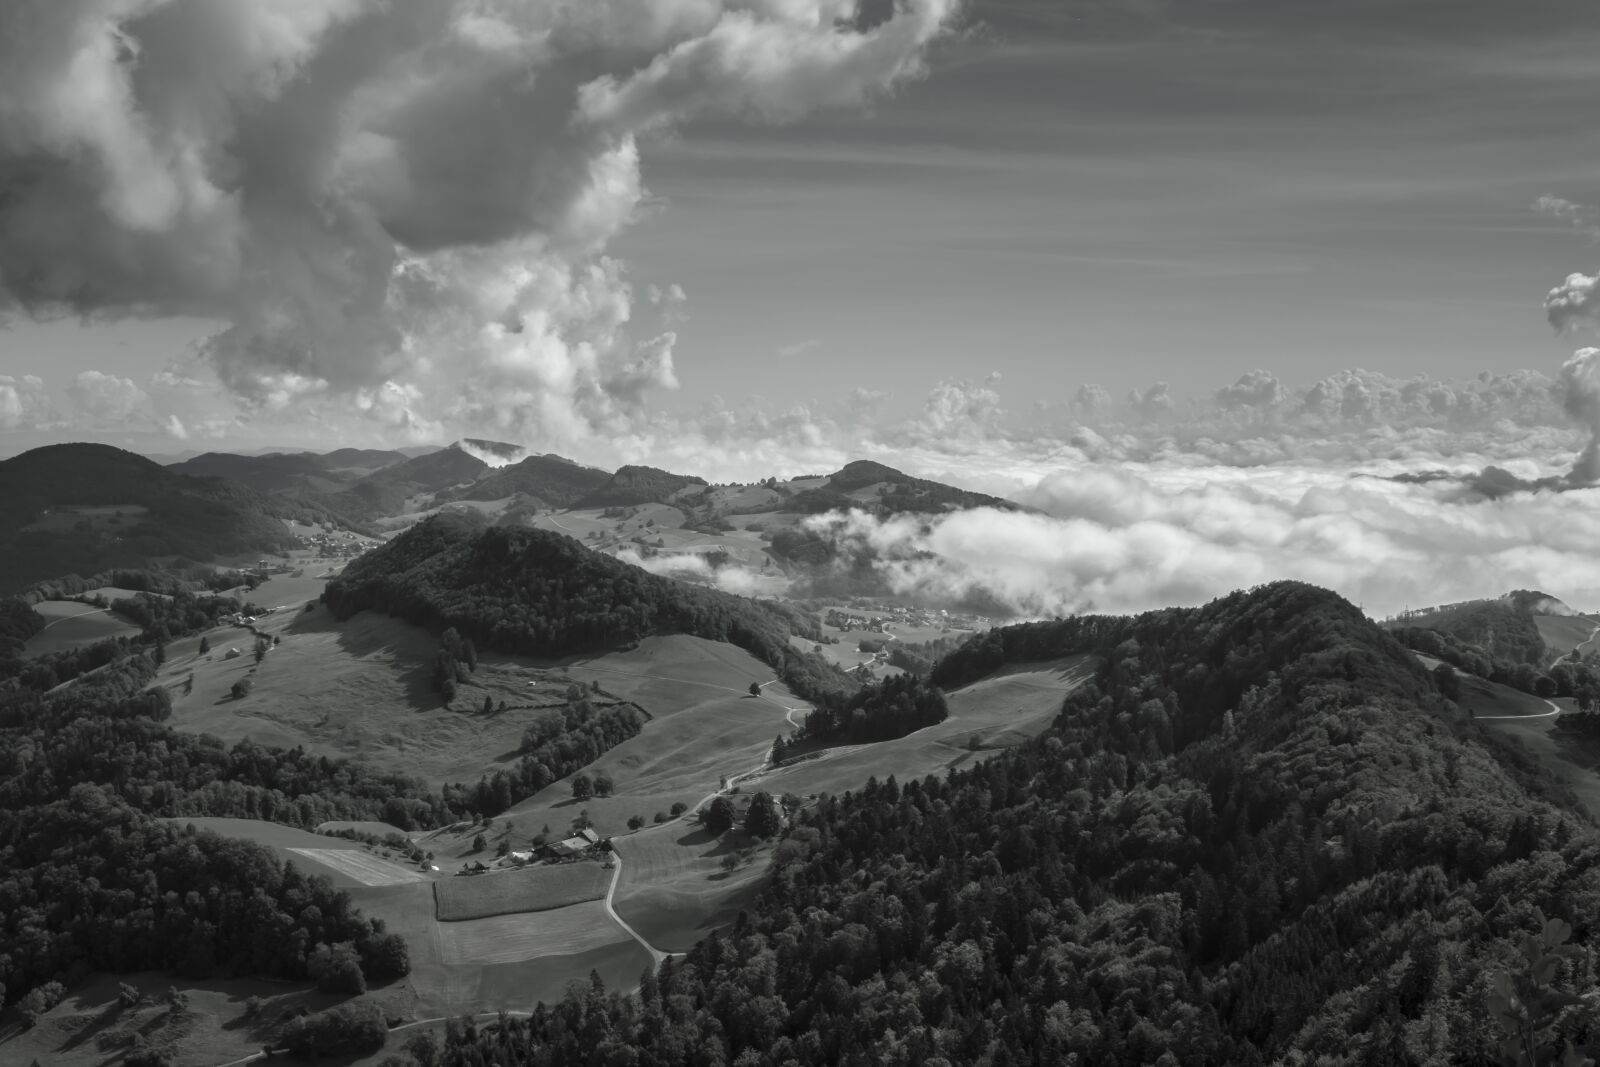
0 0 958 443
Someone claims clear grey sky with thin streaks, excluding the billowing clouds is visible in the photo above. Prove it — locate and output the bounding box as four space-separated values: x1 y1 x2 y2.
0 0 1600 450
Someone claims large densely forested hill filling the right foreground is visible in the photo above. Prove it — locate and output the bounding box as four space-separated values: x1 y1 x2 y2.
442 584 1600 1067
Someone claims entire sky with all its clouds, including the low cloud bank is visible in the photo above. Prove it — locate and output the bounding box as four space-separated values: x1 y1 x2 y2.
0 0 1600 613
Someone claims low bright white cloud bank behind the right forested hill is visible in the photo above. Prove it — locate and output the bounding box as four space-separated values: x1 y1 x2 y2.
800 464 1600 616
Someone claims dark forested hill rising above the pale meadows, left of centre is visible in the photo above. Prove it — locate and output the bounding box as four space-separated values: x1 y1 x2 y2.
323 514 856 701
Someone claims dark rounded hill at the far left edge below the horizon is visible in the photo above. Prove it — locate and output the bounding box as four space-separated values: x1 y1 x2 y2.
0 445 291 592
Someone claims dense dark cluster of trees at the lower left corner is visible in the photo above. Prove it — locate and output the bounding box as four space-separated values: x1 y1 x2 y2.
0 784 410 1001
